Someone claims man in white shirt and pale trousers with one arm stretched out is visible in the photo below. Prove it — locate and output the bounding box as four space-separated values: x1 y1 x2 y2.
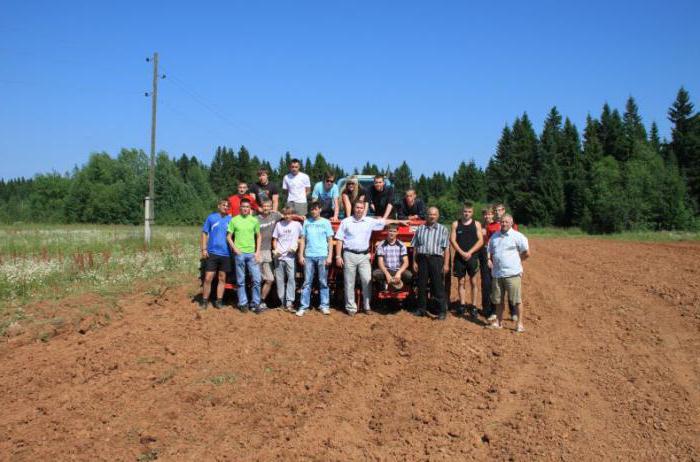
335 201 407 316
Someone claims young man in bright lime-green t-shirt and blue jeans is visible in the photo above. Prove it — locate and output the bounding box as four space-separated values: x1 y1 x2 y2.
226 199 260 313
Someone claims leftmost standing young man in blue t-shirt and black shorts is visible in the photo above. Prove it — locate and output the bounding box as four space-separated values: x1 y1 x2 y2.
199 199 231 310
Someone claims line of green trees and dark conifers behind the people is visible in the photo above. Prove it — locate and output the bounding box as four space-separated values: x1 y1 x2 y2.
0 88 700 233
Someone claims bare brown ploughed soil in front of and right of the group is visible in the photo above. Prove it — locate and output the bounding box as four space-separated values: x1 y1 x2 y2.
0 239 700 461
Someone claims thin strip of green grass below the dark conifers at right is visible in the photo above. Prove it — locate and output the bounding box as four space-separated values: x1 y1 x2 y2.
520 226 700 242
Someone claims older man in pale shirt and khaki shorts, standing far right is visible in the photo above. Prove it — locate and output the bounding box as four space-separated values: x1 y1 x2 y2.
487 214 530 332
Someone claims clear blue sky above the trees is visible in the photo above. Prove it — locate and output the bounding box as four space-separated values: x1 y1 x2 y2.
0 0 700 179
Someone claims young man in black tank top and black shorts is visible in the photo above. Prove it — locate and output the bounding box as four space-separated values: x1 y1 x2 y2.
450 202 484 319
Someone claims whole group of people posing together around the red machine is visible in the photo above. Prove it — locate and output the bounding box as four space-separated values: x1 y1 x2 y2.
200 159 529 332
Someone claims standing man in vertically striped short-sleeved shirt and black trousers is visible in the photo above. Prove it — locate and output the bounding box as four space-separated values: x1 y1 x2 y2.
411 207 450 321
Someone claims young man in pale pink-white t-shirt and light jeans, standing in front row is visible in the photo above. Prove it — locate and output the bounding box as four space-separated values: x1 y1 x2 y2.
272 206 301 312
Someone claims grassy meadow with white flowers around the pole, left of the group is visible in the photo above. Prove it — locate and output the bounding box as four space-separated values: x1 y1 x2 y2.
0 225 199 328
